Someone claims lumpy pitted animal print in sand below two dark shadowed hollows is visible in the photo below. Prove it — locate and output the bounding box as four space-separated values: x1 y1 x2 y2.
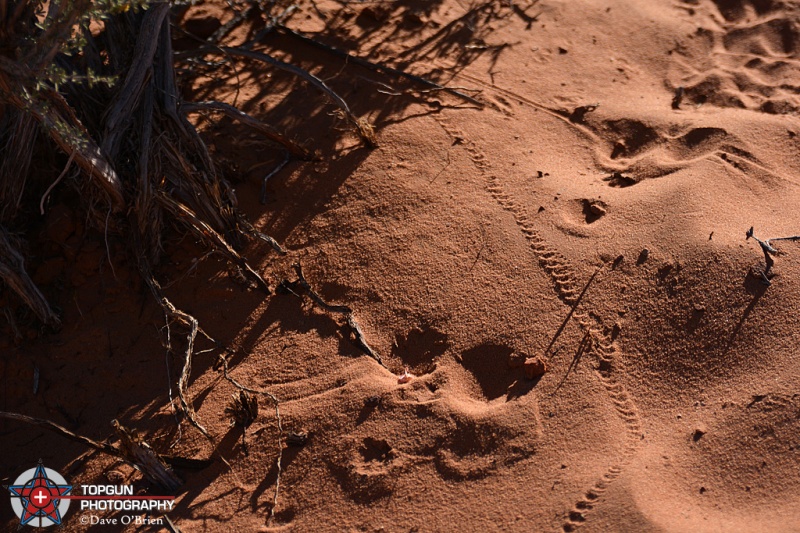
332 378 540 498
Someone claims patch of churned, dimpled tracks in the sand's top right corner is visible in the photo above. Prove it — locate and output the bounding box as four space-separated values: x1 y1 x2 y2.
672 0 800 114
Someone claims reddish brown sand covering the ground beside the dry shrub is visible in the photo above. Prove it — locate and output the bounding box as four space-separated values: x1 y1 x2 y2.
0 0 800 532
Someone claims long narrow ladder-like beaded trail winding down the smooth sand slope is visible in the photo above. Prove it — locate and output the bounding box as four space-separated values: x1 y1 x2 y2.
437 115 642 532
